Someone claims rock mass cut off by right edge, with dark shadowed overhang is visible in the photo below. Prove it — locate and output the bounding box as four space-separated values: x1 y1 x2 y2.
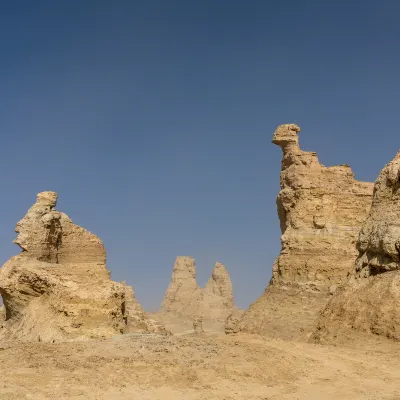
312 151 400 342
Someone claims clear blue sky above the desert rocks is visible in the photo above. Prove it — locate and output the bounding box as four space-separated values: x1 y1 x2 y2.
0 0 400 310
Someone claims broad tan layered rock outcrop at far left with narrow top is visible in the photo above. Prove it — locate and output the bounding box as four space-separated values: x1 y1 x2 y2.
0 192 163 341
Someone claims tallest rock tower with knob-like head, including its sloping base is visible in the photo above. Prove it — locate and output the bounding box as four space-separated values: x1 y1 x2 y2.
239 124 373 338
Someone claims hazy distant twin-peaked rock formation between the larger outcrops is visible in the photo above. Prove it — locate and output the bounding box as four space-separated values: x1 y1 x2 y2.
161 256 241 322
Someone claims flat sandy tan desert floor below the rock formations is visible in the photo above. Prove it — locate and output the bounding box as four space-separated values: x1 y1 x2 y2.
0 334 400 400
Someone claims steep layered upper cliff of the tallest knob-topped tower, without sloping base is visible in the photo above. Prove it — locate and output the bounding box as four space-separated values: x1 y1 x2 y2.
273 125 373 291
